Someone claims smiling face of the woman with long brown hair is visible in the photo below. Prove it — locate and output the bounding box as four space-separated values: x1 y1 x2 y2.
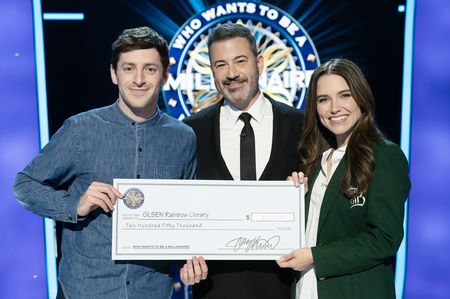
316 74 362 147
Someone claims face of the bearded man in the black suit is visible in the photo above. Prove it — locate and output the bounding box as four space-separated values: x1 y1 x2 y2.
209 37 264 111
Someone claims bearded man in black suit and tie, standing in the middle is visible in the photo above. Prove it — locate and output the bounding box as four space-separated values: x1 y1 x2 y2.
180 23 303 299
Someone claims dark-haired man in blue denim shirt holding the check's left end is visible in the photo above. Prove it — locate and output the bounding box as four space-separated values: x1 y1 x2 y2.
14 27 196 299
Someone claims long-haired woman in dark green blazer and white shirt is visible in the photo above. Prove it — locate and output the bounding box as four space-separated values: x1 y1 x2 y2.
278 59 411 299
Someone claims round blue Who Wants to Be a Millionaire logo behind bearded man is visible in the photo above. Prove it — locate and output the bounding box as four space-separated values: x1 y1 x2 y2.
164 1 320 119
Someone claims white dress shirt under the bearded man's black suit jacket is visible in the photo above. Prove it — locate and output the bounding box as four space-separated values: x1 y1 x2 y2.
220 93 273 180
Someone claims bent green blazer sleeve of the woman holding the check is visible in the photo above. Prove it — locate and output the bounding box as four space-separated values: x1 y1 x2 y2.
312 144 410 278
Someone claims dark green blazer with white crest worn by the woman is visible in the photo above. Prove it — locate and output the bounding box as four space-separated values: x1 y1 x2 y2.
305 140 411 299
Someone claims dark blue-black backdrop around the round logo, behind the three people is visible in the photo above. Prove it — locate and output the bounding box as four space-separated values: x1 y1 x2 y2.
42 0 405 143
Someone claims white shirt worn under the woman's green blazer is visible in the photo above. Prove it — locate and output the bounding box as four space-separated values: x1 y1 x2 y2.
295 145 347 299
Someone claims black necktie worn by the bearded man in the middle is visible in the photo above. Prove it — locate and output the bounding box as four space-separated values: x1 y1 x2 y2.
239 112 256 181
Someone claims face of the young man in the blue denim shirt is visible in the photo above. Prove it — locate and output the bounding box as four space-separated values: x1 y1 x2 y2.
110 48 168 121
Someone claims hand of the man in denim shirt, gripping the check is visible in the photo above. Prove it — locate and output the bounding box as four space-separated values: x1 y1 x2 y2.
77 182 123 217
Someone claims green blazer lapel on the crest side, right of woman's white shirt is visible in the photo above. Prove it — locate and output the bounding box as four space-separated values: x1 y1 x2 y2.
317 156 346 235
